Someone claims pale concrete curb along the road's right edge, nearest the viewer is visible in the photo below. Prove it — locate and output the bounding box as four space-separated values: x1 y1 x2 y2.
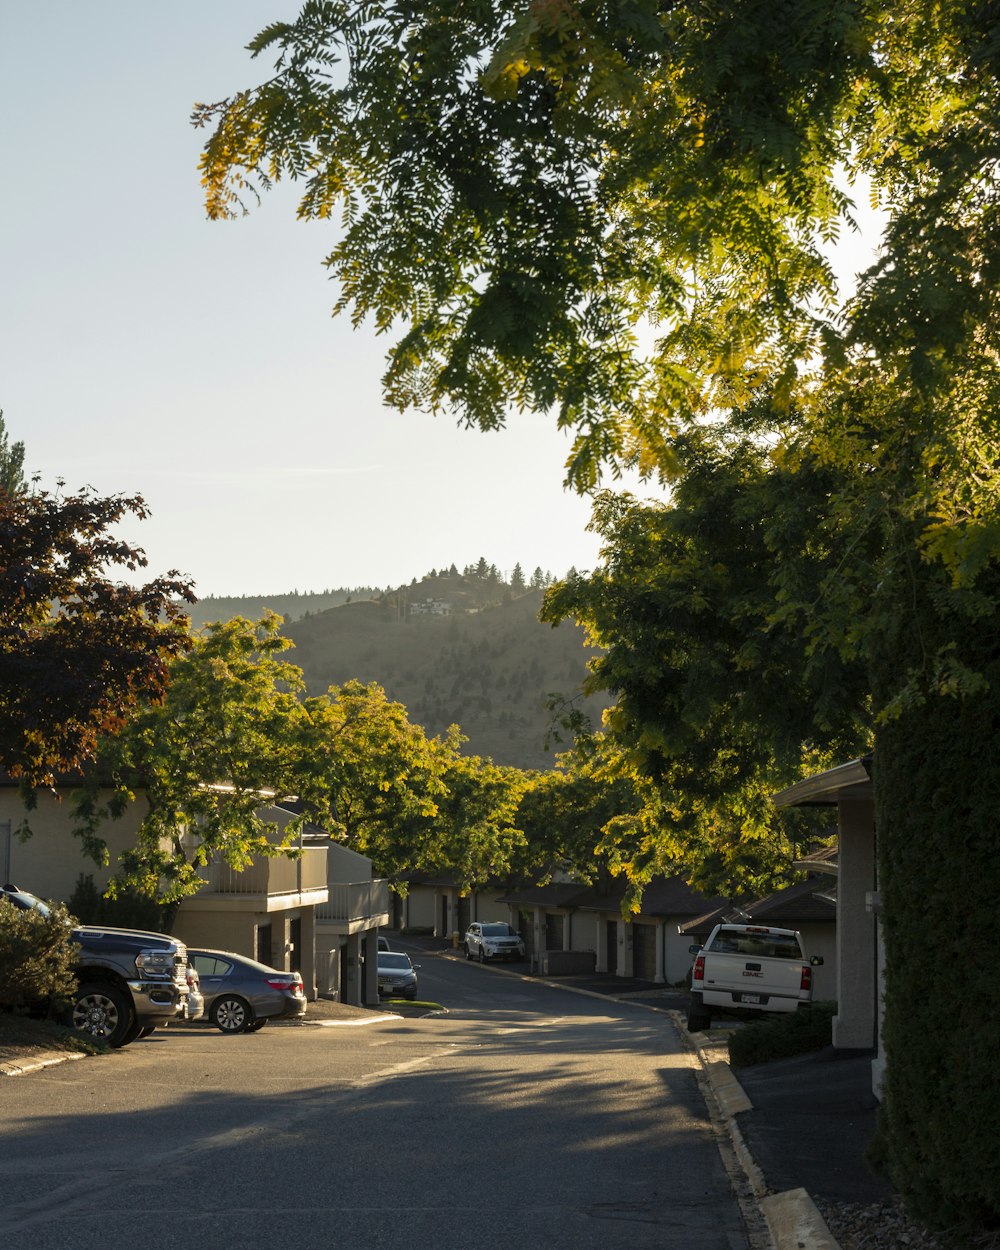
669 1011 840 1250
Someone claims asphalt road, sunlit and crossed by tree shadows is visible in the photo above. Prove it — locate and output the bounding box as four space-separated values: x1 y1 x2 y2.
0 954 749 1250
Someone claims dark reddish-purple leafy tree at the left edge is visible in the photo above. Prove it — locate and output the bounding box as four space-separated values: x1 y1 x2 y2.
0 489 194 786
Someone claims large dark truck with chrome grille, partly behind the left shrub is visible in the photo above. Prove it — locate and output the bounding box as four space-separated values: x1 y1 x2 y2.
0 884 188 1046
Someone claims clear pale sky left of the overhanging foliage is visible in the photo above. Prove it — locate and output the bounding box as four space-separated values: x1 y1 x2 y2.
0 0 875 595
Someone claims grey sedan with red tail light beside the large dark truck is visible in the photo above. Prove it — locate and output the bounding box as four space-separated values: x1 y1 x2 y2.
188 948 306 1033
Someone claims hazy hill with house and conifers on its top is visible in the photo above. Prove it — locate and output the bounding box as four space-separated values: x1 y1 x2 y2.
285 578 606 768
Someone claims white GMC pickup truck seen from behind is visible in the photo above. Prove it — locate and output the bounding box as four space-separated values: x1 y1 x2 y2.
688 925 823 1033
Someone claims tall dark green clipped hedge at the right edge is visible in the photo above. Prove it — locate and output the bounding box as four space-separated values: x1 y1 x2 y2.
875 685 1000 1238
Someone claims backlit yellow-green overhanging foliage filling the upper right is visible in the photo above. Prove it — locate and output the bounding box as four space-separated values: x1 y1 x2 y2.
194 0 998 512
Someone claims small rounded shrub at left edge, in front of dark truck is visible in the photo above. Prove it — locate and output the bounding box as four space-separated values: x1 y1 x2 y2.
0 899 80 1011
